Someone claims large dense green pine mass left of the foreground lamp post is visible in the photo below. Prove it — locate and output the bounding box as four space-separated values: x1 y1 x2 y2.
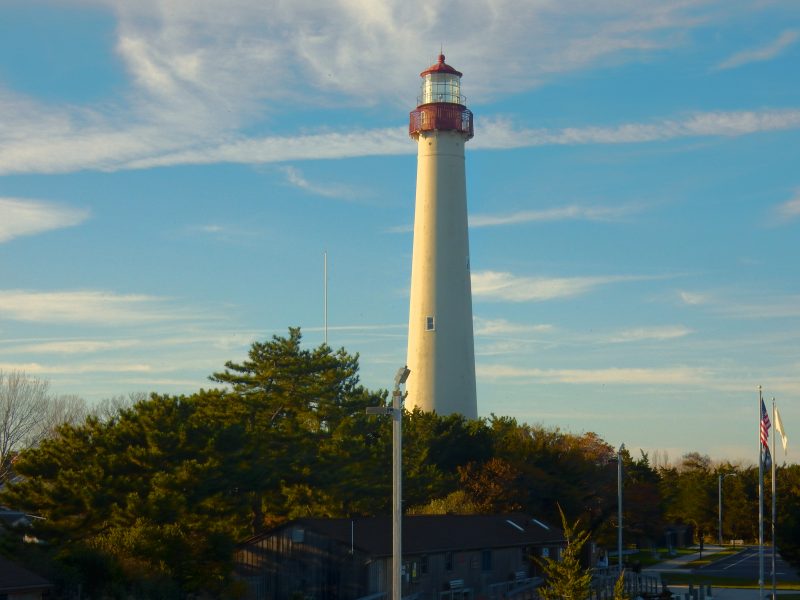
0 329 382 598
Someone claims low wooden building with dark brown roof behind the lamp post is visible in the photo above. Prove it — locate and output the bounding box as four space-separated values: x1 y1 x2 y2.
236 513 564 600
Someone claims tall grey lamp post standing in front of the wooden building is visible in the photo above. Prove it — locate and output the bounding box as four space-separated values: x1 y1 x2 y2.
367 366 411 600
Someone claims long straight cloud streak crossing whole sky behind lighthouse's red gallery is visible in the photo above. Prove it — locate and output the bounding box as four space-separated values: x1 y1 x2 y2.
0 77 800 173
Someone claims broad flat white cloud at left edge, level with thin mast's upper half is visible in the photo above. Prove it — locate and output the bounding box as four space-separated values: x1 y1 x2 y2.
0 290 189 326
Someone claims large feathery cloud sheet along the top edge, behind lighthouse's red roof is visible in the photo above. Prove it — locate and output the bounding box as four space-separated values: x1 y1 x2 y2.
98 0 703 113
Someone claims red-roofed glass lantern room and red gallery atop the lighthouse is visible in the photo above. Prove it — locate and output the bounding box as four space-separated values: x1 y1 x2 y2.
408 54 475 139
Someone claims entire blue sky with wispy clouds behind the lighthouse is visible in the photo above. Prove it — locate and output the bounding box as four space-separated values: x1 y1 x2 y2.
0 0 800 462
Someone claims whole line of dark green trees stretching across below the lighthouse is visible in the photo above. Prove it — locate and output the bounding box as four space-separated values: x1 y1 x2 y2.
0 329 800 598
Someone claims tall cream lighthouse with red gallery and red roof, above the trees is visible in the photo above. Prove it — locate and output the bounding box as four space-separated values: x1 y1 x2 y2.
406 54 478 419
